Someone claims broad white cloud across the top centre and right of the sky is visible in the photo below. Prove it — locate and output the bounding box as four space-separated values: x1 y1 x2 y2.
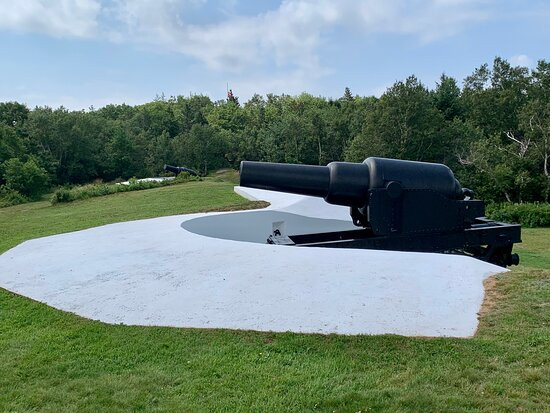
103 0 488 72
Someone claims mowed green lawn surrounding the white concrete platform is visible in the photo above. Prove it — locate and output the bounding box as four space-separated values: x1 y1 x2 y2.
0 180 550 412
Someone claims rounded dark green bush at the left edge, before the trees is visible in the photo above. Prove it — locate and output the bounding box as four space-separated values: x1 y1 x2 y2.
2 158 49 199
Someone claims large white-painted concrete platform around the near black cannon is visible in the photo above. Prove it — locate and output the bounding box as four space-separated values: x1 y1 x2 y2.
0 188 504 337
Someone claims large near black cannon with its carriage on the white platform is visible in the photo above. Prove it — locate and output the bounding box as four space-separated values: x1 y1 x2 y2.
240 157 521 267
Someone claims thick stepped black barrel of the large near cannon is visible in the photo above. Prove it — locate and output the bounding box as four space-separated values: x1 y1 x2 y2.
240 157 464 207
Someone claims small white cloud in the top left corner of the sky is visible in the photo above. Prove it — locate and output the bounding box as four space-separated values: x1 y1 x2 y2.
0 0 101 37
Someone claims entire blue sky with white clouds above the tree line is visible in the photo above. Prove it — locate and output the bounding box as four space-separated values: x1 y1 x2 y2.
0 0 550 109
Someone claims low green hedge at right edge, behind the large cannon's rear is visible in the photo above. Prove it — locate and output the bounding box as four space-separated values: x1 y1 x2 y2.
486 203 550 228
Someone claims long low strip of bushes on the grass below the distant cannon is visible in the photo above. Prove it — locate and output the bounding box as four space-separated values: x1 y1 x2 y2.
51 173 200 204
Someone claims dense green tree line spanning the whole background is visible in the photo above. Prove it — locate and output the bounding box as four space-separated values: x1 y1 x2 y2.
0 58 550 202
